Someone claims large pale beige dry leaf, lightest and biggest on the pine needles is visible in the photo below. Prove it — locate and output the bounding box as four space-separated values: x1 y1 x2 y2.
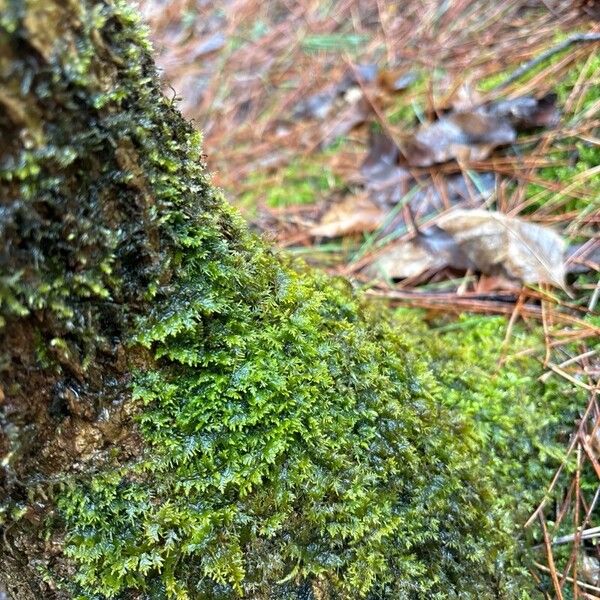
437 209 565 287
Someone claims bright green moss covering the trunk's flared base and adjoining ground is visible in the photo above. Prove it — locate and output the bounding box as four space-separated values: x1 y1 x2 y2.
55 294 582 599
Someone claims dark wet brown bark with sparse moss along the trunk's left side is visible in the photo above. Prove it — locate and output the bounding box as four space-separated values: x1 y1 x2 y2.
0 0 204 600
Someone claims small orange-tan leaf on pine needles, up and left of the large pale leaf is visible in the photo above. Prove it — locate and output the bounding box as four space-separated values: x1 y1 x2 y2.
310 196 385 237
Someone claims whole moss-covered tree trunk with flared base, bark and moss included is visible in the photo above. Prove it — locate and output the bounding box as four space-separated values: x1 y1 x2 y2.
0 0 536 600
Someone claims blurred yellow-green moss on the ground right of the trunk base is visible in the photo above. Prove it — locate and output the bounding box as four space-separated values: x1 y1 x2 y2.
410 316 586 506
